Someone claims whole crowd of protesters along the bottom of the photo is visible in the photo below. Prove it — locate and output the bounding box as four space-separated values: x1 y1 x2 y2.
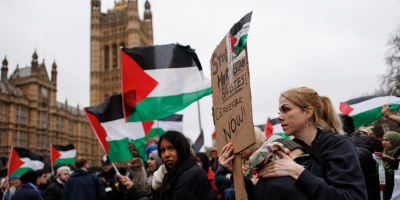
1 87 400 200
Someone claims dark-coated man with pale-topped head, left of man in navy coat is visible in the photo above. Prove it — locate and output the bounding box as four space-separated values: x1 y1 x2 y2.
46 166 71 200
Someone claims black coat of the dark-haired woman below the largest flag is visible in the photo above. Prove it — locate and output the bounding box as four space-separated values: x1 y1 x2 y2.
156 155 216 200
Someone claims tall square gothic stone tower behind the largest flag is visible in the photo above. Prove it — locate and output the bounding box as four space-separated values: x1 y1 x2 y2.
90 0 153 106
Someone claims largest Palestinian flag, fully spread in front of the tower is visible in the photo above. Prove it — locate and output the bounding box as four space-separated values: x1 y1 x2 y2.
121 44 211 122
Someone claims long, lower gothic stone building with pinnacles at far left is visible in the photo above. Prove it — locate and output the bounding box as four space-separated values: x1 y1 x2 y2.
0 51 103 167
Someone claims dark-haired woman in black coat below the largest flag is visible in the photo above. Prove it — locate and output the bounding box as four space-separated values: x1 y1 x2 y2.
155 131 216 200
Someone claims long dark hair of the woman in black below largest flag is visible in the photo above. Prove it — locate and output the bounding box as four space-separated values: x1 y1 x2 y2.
155 131 191 200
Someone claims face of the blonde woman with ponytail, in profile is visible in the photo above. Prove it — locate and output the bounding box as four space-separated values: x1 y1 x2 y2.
278 97 311 136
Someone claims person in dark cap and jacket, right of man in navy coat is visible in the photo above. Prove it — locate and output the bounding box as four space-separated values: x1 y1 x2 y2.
99 155 126 200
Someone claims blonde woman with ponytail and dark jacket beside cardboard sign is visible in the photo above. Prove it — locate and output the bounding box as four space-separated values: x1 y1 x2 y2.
220 87 368 200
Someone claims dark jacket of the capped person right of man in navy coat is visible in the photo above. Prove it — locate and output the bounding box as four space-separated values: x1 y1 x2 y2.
99 168 126 200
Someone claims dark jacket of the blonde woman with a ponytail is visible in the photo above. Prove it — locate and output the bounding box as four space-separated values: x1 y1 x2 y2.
245 130 367 200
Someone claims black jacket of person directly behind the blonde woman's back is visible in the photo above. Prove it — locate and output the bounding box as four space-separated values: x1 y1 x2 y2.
349 131 381 200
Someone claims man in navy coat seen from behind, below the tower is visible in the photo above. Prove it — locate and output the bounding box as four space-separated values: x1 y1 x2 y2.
62 157 107 200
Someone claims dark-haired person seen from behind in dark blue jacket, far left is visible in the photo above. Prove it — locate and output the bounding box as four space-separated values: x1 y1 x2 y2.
12 171 45 200
